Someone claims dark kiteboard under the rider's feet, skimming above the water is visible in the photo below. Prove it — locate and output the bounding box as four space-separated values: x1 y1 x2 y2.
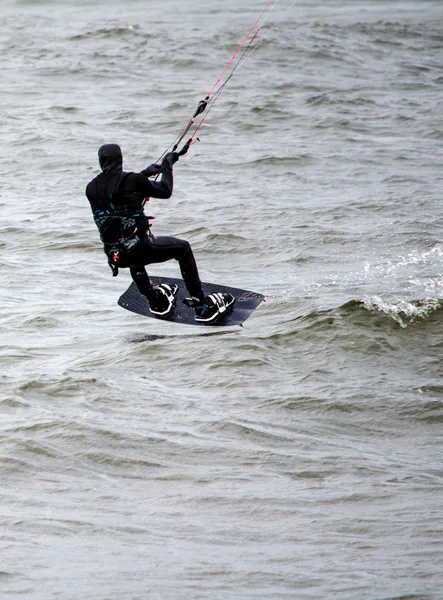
118 276 265 327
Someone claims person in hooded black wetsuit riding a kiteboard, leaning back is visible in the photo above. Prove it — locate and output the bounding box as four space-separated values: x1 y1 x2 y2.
86 144 235 321
